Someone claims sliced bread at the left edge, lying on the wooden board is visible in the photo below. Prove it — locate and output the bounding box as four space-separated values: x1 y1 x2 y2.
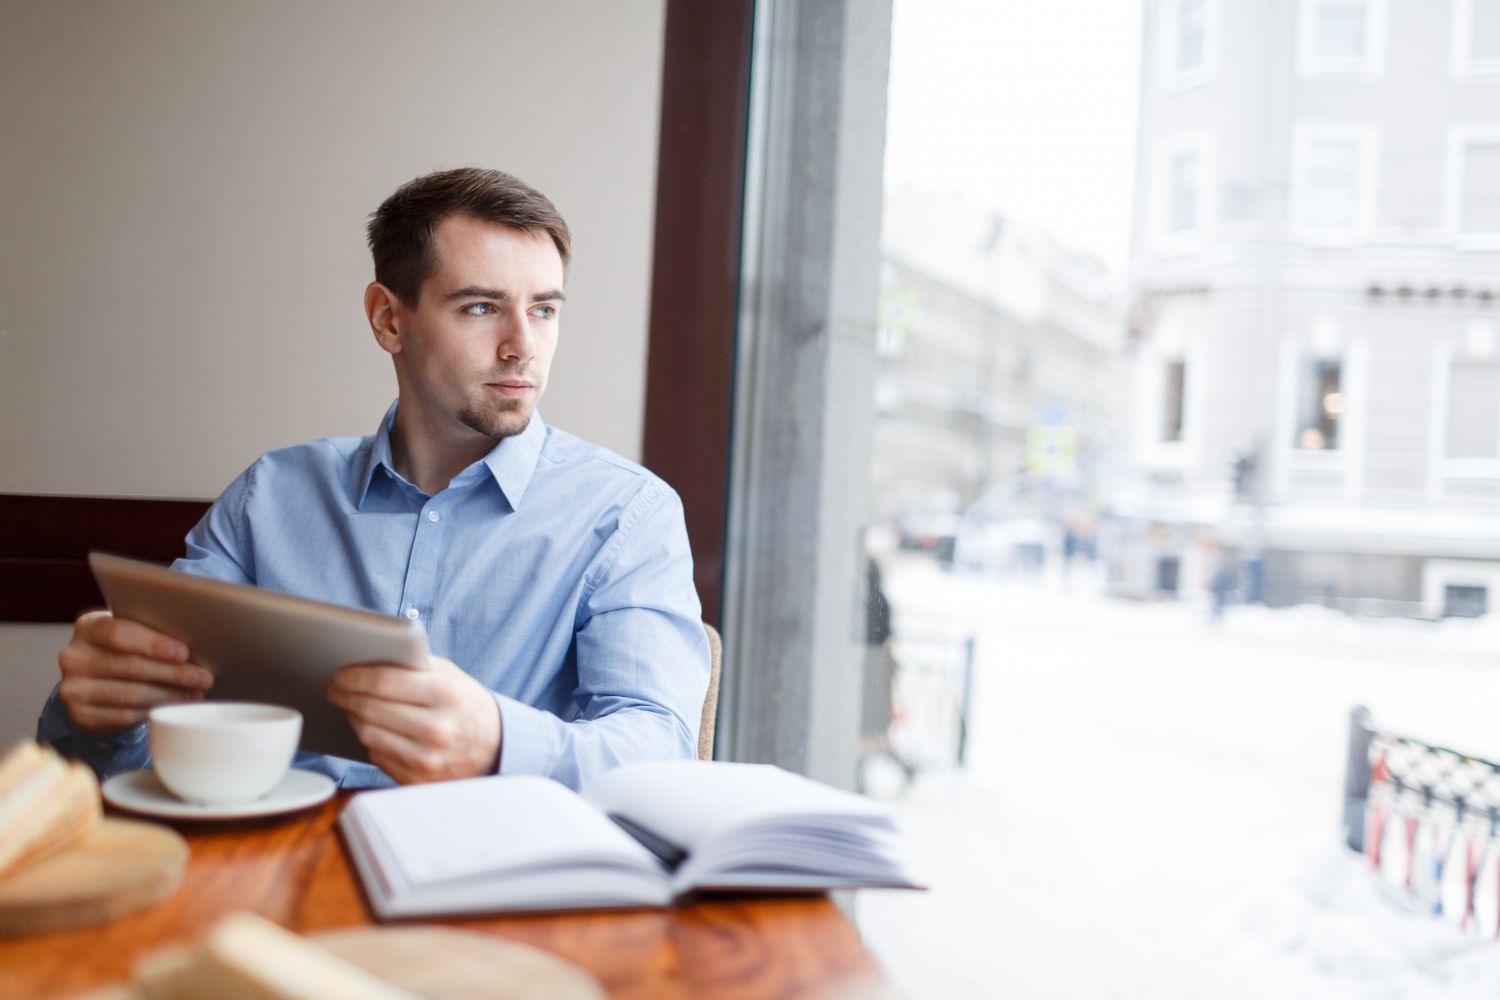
0 739 102 879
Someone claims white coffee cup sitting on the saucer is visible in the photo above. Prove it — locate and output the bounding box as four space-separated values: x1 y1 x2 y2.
150 702 302 805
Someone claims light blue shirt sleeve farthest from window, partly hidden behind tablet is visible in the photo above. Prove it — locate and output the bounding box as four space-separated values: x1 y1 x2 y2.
36 466 255 780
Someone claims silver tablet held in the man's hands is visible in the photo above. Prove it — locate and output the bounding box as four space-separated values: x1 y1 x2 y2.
89 552 428 760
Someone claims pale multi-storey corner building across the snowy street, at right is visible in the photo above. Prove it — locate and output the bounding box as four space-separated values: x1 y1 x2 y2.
1112 0 1500 618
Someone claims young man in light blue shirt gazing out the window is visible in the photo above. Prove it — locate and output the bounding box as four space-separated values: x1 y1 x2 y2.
38 168 708 787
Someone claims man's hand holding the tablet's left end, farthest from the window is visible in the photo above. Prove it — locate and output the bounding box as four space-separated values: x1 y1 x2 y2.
57 612 213 736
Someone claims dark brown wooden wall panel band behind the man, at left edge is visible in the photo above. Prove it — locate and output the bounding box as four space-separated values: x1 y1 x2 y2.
0 493 209 622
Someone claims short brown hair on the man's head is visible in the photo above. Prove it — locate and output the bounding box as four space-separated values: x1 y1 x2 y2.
368 166 573 306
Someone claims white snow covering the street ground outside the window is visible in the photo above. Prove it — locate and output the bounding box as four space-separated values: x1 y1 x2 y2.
857 558 1500 1000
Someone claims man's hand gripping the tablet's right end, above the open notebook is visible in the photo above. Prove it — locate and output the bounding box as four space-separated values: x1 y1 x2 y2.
329 657 501 784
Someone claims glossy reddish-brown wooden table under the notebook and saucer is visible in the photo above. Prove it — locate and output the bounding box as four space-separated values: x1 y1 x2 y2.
0 793 893 1000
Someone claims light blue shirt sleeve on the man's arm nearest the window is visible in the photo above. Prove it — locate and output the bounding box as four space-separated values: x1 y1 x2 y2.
495 483 710 789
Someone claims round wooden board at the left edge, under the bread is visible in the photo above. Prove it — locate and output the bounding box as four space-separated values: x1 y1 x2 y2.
0 819 188 937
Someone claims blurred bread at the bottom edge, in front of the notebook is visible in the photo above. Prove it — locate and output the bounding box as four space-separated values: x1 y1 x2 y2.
135 913 416 1000
